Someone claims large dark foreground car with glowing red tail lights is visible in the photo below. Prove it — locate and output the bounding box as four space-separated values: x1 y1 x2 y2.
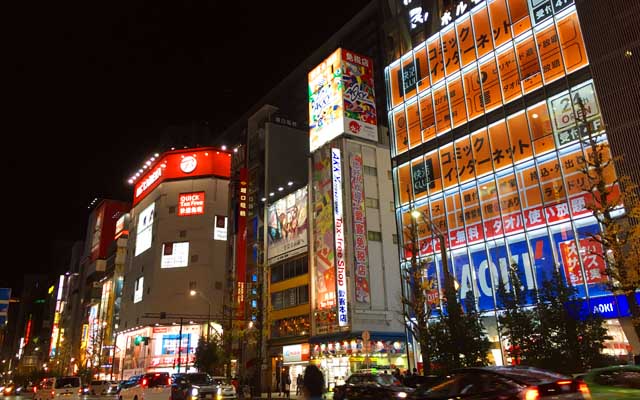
410 367 591 400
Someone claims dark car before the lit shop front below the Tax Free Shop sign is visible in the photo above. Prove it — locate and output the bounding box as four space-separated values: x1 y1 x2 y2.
333 372 413 400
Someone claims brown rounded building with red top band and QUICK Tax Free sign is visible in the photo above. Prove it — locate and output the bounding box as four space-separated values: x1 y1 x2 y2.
114 147 231 379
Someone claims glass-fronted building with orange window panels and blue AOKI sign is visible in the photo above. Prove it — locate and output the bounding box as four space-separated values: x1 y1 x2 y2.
385 0 640 365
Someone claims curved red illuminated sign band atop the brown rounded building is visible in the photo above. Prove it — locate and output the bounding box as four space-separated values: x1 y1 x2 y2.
133 147 231 205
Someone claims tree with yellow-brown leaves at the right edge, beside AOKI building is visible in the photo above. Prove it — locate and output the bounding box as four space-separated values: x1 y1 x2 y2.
575 96 640 337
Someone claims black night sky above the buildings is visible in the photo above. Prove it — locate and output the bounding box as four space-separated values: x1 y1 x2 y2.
5 0 368 285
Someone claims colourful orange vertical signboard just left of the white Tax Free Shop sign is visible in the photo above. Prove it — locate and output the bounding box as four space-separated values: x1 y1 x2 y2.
312 147 336 332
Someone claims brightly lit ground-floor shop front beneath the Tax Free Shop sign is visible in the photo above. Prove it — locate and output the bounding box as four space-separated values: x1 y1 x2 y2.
310 333 408 390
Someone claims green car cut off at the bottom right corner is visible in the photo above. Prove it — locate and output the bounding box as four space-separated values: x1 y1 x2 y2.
578 365 640 400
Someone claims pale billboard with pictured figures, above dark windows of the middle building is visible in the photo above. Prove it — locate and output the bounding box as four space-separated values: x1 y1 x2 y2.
267 186 308 263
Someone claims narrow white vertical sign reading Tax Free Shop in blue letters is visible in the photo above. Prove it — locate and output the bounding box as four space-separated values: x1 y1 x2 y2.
331 149 349 326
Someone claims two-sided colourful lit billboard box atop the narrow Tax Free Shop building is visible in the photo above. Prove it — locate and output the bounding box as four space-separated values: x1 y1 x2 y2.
308 48 378 152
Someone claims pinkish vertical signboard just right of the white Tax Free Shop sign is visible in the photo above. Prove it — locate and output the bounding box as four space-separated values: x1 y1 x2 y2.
349 154 371 304
